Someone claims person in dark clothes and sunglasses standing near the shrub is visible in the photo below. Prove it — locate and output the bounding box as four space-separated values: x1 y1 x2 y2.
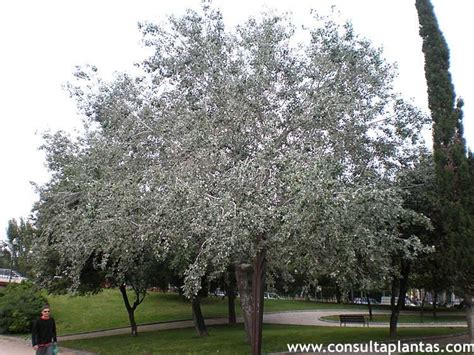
31 305 57 355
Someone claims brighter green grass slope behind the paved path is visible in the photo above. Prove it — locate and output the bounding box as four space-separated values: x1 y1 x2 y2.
48 289 367 335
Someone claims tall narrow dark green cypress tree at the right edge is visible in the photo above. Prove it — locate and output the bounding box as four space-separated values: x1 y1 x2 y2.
416 0 474 341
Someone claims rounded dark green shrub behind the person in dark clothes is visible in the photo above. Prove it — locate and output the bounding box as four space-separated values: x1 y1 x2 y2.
0 282 47 334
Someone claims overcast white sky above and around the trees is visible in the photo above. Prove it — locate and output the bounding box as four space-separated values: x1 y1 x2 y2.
0 0 474 239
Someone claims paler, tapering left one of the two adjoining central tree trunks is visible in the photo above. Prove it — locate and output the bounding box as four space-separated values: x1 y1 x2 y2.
235 264 253 344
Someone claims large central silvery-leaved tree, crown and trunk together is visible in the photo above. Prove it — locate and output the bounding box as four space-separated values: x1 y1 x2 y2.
136 9 423 352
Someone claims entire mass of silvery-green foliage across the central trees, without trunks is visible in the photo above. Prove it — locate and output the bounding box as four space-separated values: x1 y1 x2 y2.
36 6 426 295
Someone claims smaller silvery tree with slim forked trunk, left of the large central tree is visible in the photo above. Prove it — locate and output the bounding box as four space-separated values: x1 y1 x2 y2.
36 128 163 335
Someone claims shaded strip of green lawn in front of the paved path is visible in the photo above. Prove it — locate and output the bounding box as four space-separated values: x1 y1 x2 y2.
60 324 465 354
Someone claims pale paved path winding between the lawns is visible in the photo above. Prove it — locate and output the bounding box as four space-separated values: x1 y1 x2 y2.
0 309 467 355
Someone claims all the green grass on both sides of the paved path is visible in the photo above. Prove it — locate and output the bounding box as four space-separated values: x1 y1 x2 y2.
48 290 465 354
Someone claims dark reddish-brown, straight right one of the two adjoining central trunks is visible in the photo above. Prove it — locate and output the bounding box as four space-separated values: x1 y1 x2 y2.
252 243 267 355
